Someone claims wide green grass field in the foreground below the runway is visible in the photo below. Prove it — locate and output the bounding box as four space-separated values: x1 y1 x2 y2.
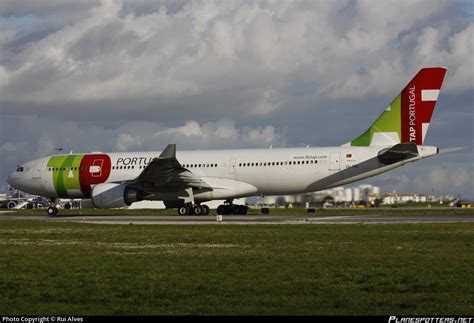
0 221 474 315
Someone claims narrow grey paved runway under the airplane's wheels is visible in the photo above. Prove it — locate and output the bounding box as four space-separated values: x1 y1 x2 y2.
0 213 474 225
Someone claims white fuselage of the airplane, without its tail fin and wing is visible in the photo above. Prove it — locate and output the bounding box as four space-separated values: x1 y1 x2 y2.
8 146 437 201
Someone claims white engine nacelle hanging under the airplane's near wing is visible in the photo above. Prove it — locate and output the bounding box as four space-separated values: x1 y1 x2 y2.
91 183 141 209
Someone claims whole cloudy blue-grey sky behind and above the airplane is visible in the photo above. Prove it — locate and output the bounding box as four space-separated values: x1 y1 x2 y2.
0 0 474 198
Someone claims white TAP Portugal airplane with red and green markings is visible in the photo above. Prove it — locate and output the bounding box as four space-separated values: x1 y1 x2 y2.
8 67 447 216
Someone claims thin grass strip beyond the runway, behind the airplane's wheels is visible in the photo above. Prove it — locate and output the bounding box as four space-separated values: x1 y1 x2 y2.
5 208 474 216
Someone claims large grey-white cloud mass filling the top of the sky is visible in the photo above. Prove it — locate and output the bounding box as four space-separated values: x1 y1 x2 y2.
0 0 474 109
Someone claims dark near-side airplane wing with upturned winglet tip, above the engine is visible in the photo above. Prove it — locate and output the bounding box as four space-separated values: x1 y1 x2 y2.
128 144 212 192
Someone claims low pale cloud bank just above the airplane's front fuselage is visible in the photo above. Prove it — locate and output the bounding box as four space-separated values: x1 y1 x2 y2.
0 116 287 159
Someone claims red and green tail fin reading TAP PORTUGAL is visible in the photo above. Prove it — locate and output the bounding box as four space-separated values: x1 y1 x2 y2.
344 67 446 146
